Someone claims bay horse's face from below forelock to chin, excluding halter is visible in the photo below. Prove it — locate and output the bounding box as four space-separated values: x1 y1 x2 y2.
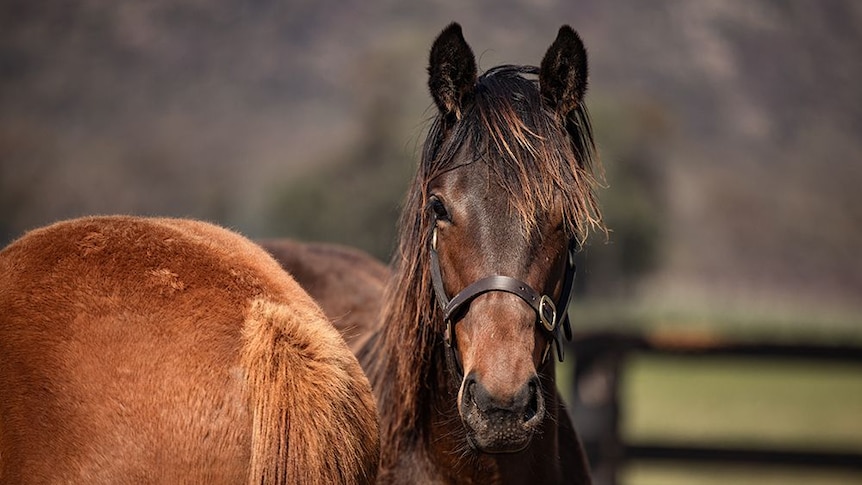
429 156 568 452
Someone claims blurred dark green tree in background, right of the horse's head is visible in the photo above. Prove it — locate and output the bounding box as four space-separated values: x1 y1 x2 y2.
579 100 670 297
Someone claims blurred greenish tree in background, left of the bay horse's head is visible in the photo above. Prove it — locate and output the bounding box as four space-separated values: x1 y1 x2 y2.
266 53 418 261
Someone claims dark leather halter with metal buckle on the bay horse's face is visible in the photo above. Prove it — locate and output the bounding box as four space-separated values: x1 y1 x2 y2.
430 228 577 362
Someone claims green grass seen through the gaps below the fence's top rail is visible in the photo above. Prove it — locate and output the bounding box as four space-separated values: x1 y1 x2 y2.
621 356 862 485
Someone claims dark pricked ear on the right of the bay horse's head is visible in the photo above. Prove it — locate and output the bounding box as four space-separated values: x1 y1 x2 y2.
539 25 587 117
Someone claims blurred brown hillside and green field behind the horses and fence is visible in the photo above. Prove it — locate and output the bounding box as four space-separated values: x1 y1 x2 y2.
0 0 862 484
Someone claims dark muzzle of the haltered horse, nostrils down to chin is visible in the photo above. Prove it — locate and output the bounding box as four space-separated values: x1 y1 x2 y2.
459 373 545 453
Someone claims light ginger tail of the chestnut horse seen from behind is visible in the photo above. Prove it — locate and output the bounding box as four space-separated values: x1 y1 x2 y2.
243 300 379 485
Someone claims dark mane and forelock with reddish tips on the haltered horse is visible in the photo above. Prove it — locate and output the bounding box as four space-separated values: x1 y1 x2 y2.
366 65 603 458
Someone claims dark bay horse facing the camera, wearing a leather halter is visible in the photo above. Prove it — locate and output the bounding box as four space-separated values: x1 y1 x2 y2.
268 23 604 484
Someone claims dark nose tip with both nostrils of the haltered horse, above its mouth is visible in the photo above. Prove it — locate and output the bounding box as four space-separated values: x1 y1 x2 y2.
462 373 544 424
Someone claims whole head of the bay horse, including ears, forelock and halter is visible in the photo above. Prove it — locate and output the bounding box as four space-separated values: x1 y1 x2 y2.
422 24 598 452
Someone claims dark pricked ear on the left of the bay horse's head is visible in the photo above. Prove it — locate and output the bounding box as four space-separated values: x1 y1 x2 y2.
428 22 476 118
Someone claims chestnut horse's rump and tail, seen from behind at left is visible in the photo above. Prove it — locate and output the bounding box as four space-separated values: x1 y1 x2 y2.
0 216 379 485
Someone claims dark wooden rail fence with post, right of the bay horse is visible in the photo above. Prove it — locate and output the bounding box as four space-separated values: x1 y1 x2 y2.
568 332 862 485
